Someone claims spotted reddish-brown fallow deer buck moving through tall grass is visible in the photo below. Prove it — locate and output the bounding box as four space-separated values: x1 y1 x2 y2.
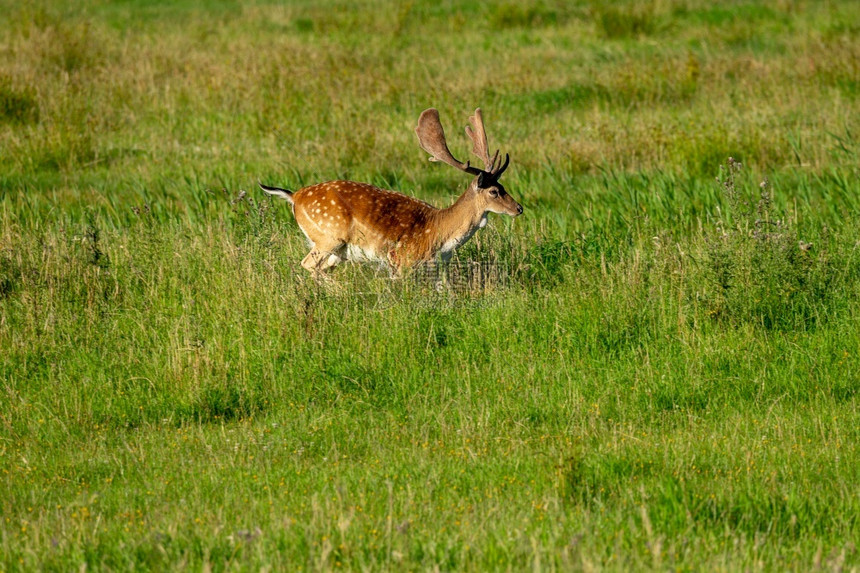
260 108 523 274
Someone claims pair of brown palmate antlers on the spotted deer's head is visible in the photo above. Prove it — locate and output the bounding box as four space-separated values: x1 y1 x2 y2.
415 108 510 179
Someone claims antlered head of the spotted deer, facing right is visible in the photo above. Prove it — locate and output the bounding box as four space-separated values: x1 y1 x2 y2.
415 108 523 217
